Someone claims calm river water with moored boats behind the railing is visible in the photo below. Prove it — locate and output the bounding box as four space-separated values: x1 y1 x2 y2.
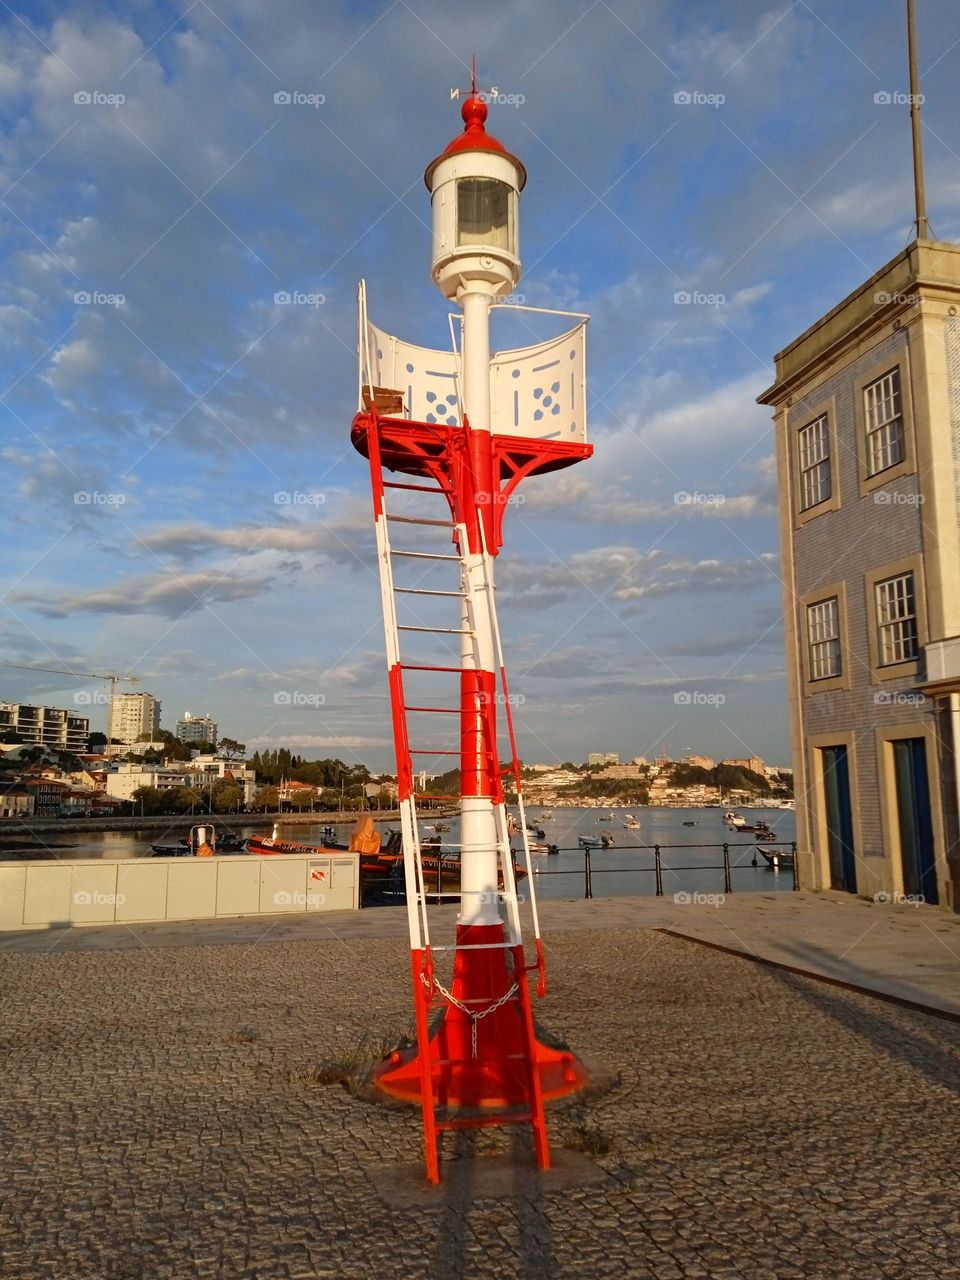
26 805 796 897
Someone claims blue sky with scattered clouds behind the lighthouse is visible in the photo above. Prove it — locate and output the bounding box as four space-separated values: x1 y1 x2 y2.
0 0 960 768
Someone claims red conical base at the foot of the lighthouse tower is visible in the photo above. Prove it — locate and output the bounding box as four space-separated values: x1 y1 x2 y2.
374 924 589 1110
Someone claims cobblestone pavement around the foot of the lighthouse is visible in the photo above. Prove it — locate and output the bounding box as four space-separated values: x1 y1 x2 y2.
0 929 960 1280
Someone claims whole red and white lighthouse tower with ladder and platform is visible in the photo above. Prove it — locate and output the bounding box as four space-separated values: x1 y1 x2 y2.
352 87 593 1181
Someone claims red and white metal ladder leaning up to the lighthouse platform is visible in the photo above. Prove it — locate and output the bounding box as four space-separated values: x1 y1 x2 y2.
364 412 573 1183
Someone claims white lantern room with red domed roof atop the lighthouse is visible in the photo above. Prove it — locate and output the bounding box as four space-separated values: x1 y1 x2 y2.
424 93 526 298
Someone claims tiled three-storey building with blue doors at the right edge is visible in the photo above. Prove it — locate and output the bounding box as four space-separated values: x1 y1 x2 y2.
760 239 960 909
